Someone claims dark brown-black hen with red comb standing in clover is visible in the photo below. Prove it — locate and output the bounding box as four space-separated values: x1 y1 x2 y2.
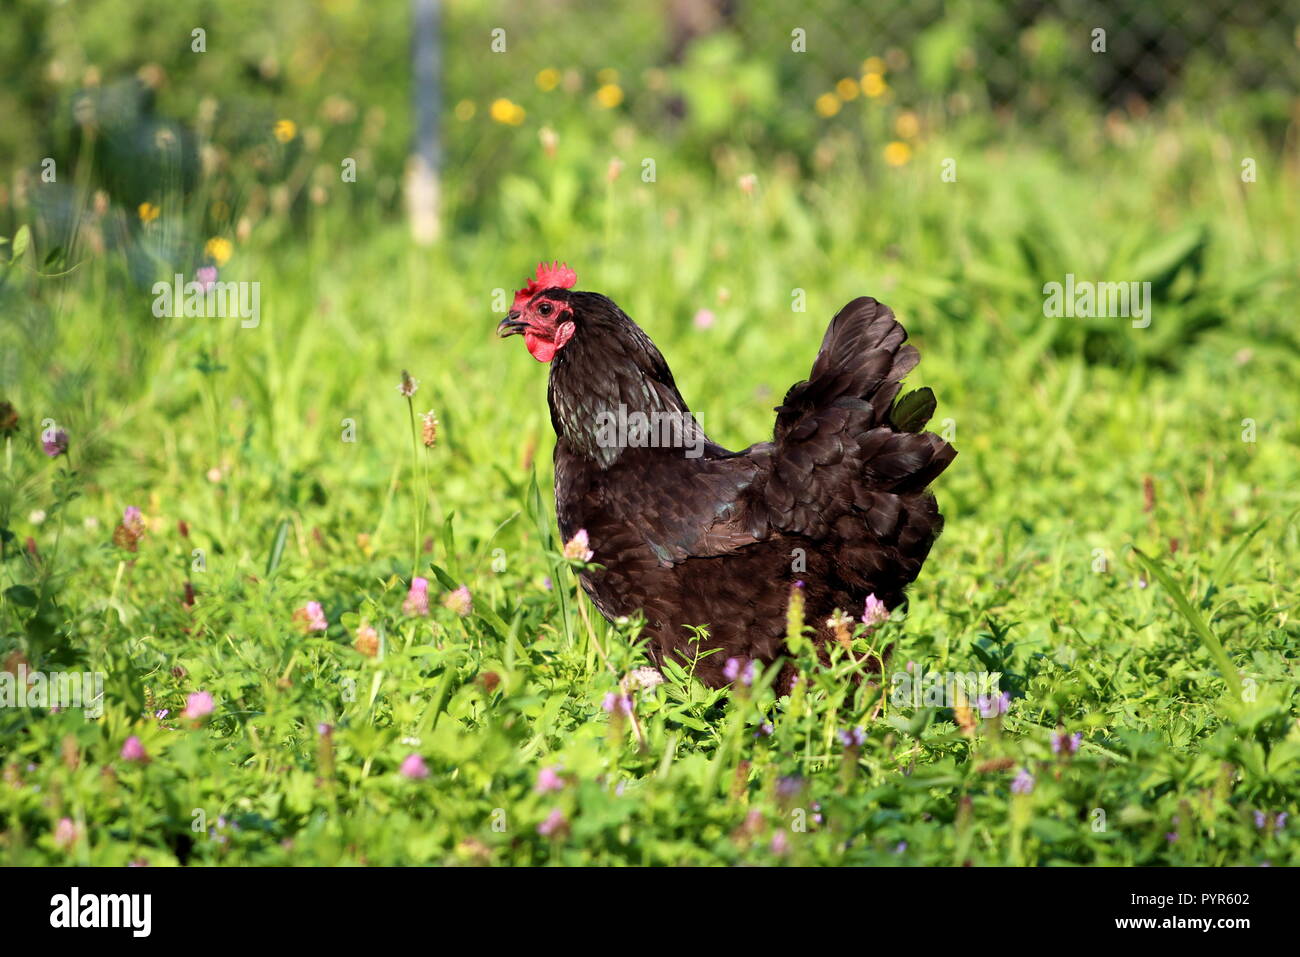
497 264 957 688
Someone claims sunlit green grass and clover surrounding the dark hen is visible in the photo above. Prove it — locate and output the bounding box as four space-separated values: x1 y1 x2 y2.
0 104 1300 865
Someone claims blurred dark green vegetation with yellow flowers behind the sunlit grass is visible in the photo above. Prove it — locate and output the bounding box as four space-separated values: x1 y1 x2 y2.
0 0 1300 273
